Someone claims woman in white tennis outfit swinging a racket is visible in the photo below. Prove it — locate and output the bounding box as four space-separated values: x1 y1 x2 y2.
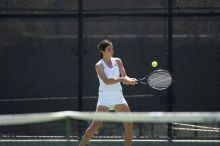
79 39 137 146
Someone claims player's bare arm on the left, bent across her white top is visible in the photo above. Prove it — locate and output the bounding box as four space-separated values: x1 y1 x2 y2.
95 63 126 85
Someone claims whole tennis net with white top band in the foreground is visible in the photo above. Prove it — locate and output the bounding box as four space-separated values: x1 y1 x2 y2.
0 111 220 146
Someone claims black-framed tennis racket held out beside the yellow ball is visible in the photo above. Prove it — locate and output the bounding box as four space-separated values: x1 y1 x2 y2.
138 69 172 90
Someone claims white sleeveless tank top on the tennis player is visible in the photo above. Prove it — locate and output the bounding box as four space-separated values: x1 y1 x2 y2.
98 57 122 93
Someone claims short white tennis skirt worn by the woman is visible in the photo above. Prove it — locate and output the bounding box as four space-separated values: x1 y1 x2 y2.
97 91 127 110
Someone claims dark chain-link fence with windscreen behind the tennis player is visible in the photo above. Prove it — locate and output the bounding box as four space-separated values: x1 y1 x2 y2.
0 0 220 138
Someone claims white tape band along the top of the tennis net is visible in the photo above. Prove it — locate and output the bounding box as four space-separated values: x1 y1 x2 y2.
0 111 220 125
